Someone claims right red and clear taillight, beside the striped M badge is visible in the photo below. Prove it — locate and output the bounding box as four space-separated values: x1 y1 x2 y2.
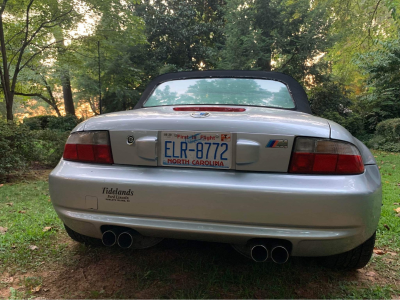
289 138 364 175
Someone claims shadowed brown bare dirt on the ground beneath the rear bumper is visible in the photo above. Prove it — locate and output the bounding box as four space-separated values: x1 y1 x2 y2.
36 239 378 298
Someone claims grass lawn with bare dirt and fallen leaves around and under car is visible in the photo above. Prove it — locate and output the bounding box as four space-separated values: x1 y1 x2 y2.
0 152 400 298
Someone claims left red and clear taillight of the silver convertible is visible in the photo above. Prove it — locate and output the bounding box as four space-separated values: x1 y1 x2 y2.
63 131 113 164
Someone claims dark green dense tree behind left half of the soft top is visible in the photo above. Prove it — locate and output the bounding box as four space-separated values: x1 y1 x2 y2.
136 0 223 70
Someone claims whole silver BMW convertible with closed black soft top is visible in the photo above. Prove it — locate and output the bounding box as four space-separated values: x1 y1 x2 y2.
49 71 382 269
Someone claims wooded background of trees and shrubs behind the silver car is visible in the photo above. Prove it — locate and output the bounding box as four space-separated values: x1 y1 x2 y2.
0 0 400 177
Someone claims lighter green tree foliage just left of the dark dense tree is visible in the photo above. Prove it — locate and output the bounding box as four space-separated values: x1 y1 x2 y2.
70 0 146 114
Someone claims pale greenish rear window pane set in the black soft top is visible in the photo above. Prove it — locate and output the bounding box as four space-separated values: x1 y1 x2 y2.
143 78 295 109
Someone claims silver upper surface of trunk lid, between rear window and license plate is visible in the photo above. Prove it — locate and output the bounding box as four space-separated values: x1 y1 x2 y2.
77 106 330 138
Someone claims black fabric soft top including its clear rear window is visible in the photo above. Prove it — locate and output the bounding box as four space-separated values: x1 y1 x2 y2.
135 71 311 114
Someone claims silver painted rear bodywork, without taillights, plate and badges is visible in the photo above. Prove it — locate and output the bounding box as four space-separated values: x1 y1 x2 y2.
53 107 382 256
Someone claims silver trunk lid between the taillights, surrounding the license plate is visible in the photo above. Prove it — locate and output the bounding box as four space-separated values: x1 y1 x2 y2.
84 106 330 172
